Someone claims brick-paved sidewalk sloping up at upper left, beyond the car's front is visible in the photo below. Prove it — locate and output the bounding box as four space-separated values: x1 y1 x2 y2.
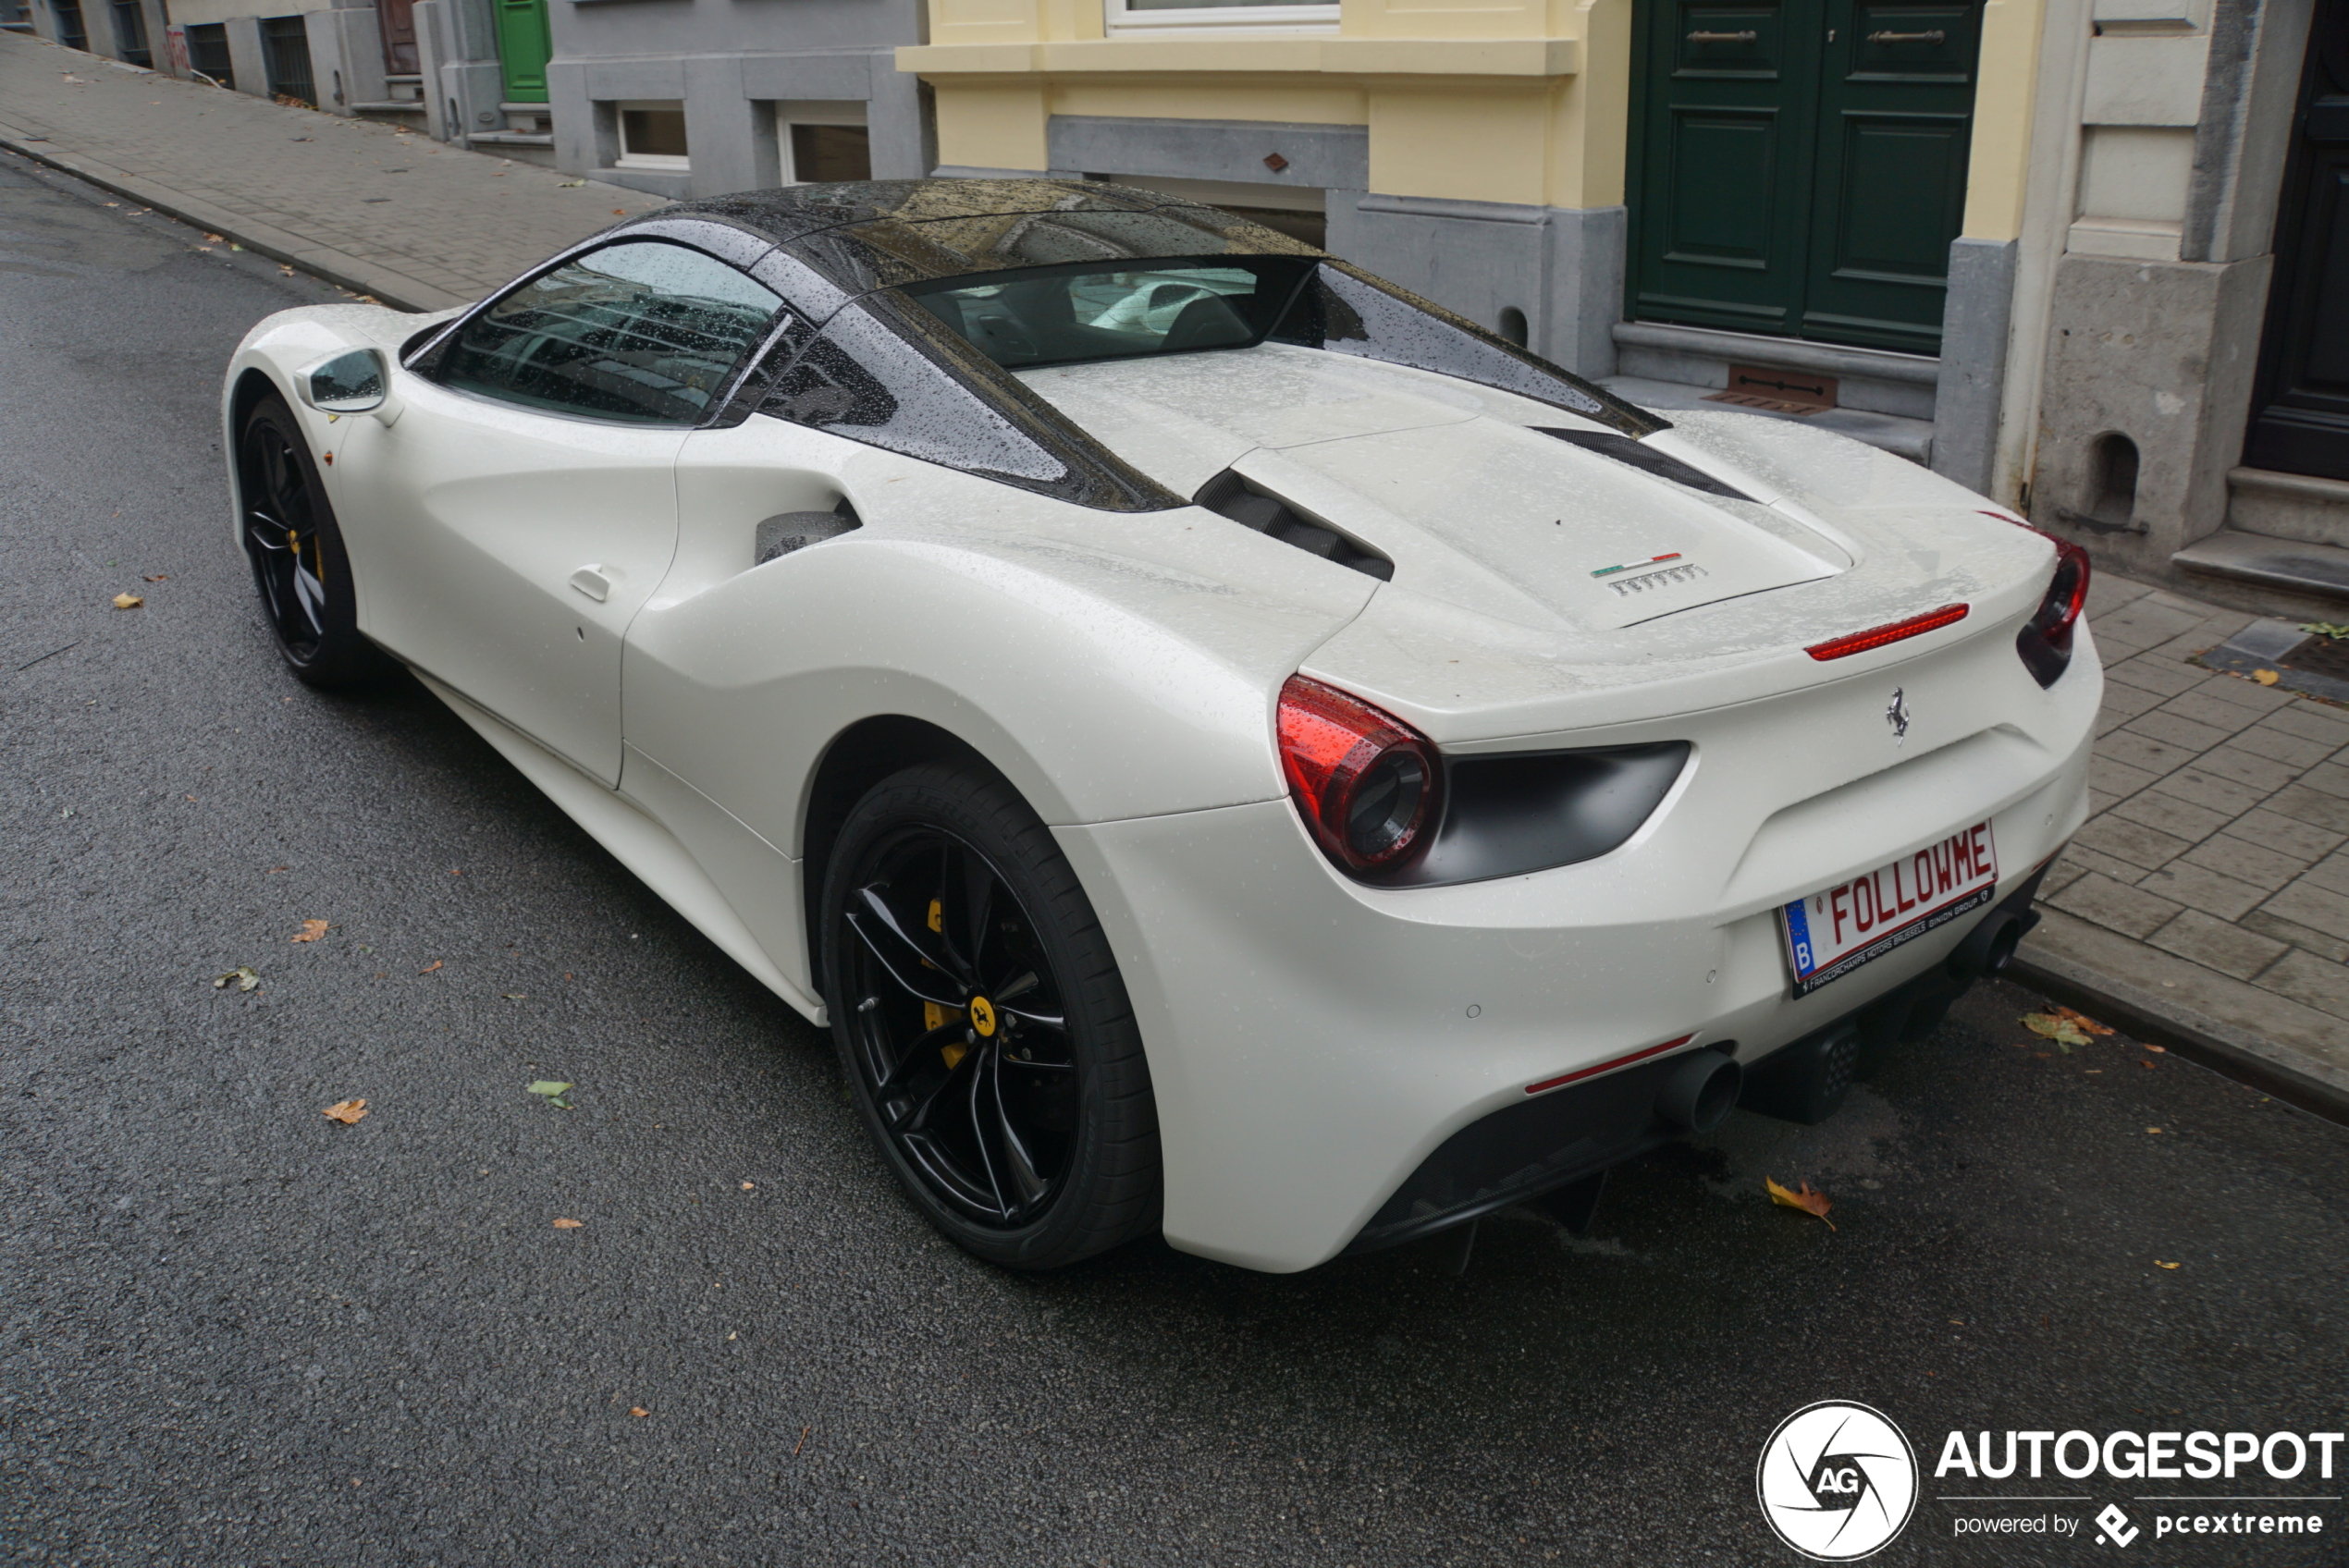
0 33 665 310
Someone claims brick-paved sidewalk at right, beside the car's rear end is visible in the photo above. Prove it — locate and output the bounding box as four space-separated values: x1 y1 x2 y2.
2020 575 2349 1110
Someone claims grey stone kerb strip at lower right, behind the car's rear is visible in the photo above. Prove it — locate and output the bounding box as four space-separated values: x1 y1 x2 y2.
2006 911 2349 1127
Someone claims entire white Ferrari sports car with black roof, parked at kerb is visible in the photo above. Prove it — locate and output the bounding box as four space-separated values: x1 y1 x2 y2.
223 180 2102 1270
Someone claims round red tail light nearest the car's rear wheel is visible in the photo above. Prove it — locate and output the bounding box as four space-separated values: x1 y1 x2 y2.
1280 676 1445 871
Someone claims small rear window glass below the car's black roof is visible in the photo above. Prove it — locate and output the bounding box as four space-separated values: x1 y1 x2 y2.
904 256 1315 369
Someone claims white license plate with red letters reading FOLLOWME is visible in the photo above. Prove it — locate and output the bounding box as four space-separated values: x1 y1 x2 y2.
1778 822 1999 996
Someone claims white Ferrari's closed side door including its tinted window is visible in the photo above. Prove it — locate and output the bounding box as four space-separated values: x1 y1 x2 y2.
350 239 780 784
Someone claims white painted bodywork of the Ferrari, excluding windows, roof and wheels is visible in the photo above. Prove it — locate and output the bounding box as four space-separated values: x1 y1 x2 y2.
228 251 2100 1270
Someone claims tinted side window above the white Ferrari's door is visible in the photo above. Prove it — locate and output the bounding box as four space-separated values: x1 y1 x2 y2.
439 239 782 425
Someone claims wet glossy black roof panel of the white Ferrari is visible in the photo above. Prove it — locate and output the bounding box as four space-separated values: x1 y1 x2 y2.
643 178 1322 293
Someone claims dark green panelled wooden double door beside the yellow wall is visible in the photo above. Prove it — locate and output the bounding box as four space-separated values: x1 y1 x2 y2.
1630 0 1980 354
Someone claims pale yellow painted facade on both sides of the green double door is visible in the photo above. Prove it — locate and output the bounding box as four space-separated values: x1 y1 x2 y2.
916 0 2046 227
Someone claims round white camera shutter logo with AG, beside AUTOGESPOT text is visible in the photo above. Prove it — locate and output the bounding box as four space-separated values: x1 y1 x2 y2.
1754 1399 1917 1563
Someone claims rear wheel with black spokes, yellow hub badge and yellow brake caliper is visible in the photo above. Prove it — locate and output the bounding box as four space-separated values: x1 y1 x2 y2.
822 763 1158 1270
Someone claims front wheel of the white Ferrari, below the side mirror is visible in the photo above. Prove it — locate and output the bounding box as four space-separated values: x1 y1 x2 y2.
238 392 395 688
